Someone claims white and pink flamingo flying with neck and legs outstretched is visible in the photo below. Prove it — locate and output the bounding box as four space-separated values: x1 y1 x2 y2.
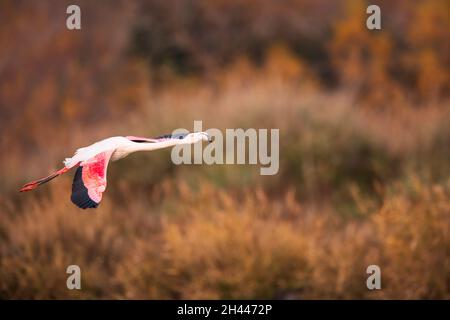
19 132 211 209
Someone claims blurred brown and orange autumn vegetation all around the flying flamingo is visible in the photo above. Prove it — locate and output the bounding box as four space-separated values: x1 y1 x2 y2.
0 0 450 299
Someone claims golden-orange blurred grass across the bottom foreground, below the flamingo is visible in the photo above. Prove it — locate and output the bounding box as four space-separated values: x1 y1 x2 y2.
0 179 450 299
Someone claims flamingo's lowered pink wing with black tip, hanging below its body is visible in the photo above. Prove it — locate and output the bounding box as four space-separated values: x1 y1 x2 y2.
70 150 115 209
